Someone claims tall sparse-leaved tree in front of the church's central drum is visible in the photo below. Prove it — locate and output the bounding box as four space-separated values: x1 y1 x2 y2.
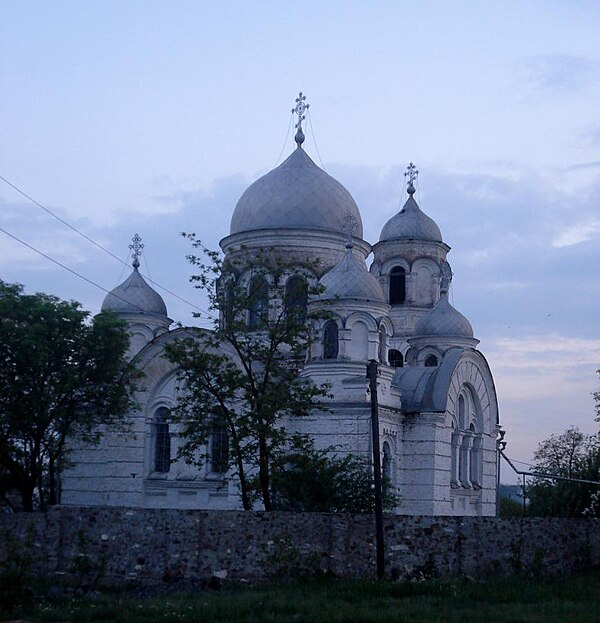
166 234 327 510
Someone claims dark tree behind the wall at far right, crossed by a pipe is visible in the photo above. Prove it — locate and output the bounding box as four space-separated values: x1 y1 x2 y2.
527 426 600 517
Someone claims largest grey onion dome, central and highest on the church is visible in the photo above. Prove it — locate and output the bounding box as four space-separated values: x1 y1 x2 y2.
230 146 362 238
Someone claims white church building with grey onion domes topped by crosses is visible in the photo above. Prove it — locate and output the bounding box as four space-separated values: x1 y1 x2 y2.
61 95 499 515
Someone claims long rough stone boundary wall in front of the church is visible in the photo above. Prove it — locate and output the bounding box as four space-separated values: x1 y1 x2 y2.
0 507 600 585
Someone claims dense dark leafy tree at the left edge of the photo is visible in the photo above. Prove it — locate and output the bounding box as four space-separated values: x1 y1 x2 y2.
0 281 135 511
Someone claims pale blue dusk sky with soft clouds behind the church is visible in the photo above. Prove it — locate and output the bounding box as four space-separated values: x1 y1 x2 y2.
0 0 600 482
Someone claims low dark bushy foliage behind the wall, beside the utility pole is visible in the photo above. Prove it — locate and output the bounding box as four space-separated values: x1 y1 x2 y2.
272 435 400 513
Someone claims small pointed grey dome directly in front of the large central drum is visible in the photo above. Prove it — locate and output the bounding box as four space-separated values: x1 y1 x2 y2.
317 248 385 303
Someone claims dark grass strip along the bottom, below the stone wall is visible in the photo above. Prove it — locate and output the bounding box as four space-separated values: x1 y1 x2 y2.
0 572 600 623
